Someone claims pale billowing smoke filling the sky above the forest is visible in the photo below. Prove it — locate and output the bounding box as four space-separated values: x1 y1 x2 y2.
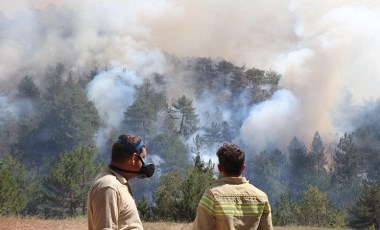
0 0 380 153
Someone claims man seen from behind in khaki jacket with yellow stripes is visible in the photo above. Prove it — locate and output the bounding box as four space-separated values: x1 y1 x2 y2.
193 144 273 230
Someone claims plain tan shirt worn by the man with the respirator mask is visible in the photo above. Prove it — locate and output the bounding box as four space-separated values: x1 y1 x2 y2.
87 168 144 230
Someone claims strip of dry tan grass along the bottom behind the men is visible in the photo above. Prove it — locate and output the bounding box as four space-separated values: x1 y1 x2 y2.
0 217 350 230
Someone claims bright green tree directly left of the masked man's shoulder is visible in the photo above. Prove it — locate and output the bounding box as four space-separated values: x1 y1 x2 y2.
45 147 100 217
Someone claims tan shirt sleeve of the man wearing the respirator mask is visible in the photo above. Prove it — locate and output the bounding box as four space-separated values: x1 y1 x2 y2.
91 188 119 229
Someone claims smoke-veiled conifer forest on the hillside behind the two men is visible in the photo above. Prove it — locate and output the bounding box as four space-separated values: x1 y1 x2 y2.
0 57 380 228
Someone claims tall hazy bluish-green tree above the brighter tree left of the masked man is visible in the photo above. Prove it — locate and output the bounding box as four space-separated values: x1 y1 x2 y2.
41 76 100 153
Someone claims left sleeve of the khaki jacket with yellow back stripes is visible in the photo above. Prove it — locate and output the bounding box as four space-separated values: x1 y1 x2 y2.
193 191 215 230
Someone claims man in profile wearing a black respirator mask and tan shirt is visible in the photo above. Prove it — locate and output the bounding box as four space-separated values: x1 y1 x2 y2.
87 134 154 230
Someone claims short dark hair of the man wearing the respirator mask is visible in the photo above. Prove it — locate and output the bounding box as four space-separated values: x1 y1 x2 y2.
111 134 145 162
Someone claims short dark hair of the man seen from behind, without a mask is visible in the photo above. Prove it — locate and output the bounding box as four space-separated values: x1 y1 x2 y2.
216 143 245 176
